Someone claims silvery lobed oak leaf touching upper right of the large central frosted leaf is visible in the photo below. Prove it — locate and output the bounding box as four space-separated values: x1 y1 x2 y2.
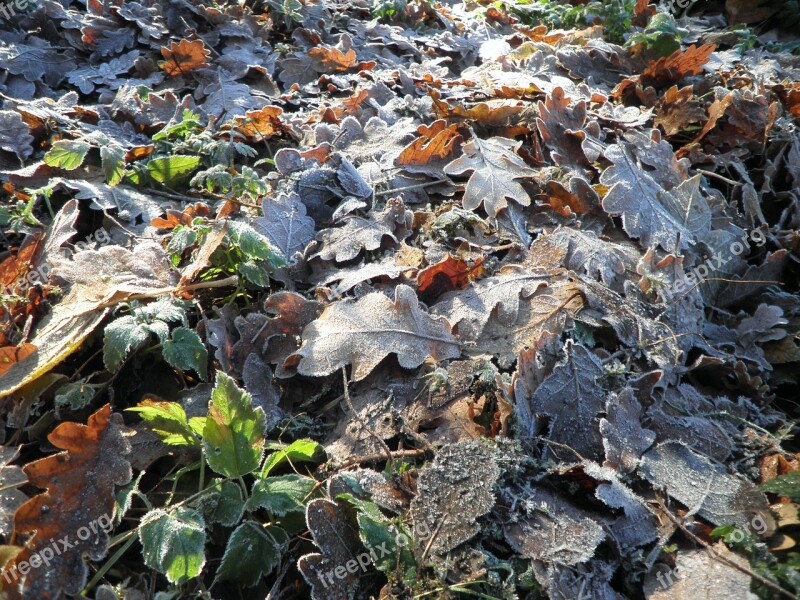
431 265 548 340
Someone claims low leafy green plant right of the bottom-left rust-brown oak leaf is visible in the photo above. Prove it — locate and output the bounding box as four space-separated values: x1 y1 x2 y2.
119 373 325 587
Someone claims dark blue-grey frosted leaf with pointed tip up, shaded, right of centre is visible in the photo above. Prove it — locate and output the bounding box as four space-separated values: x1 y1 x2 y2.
526 343 606 459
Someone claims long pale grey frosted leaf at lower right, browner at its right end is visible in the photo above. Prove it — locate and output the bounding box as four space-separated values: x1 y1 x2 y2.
639 441 771 530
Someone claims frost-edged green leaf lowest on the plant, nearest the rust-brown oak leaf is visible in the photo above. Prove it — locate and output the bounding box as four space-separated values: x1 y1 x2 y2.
139 508 206 583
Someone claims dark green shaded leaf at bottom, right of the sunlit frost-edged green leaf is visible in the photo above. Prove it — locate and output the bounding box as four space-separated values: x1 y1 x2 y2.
217 521 281 587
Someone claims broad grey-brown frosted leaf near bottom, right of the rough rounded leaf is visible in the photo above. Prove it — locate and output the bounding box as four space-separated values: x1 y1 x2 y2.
504 487 606 565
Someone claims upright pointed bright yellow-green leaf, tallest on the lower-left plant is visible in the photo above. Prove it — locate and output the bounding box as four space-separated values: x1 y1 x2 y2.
203 373 266 478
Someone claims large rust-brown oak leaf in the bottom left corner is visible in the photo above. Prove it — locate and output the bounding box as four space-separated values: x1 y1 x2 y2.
0 404 131 600
